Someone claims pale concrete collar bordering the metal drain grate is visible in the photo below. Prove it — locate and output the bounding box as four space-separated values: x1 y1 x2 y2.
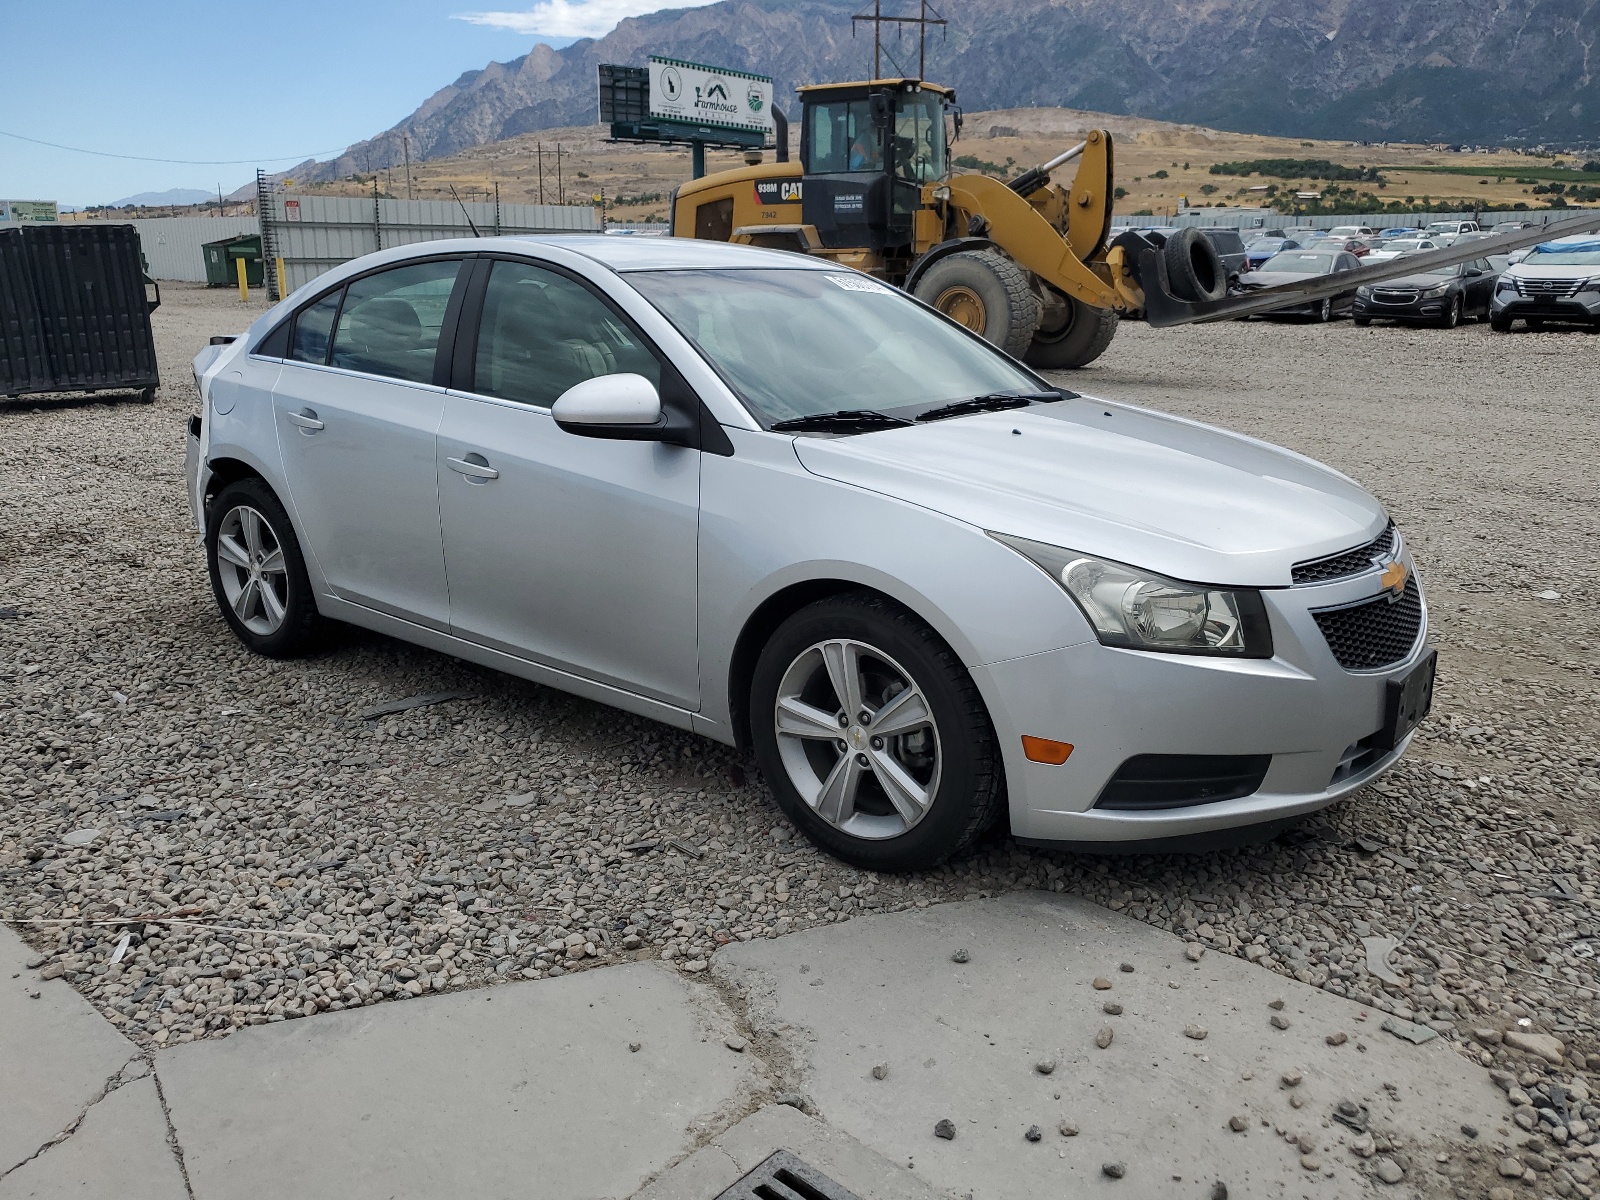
634 1104 949 1200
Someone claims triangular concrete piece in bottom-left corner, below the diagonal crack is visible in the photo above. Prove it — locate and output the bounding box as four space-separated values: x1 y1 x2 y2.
0 1081 189 1200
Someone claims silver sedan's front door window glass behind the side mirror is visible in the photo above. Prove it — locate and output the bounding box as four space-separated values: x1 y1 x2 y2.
474 262 661 408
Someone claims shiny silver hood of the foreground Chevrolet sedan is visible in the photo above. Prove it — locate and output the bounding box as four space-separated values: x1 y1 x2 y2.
795 397 1387 587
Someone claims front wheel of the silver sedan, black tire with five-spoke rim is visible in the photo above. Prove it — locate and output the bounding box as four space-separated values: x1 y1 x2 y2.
749 594 1005 872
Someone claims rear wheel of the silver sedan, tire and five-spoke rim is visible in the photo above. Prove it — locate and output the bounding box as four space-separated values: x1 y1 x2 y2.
205 477 322 658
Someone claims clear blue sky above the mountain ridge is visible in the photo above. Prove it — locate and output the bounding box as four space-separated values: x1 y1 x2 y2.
0 0 707 205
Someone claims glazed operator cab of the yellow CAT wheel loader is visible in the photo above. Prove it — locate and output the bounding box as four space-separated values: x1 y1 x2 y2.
800 78 955 256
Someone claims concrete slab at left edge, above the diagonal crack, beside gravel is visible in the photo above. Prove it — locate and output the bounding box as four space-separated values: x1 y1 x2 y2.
0 926 139 1174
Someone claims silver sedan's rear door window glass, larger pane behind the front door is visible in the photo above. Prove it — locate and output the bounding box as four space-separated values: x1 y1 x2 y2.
333 262 461 384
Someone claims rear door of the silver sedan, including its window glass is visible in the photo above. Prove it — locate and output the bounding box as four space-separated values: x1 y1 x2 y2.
272 261 461 629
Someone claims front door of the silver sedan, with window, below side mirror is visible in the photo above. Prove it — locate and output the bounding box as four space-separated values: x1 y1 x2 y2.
438 261 699 709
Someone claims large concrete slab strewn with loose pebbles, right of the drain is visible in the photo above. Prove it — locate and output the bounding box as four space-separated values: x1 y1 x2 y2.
712 893 1506 1200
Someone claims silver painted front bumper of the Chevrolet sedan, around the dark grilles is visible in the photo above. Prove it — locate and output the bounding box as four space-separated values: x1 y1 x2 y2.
974 560 1427 843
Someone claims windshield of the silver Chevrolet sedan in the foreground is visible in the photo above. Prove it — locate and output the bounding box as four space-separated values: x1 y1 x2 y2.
627 270 1042 424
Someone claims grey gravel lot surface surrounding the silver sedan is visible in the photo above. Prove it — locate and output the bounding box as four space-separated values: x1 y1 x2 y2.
0 285 1600 1195
